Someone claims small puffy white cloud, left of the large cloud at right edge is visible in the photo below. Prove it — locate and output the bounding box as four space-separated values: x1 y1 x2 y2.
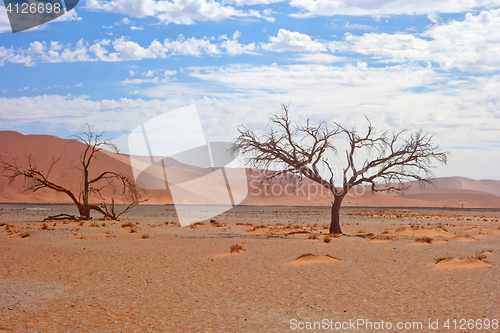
262 29 327 52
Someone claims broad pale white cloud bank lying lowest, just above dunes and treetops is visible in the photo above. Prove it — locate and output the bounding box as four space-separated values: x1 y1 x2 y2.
0 63 500 178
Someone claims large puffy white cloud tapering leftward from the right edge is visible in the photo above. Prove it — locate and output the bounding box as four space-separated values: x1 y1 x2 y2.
344 9 500 72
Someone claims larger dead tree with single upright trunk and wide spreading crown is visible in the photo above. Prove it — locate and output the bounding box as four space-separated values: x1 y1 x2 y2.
233 105 448 234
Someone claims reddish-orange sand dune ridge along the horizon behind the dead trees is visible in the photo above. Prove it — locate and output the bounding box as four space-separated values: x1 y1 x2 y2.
0 131 500 208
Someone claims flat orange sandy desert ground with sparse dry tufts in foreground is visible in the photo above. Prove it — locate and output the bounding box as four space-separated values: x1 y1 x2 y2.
0 204 500 332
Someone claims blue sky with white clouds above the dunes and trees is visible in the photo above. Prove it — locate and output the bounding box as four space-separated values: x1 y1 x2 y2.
0 0 500 179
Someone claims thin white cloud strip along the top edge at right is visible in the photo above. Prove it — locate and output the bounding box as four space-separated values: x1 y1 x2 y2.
290 0 498 18
